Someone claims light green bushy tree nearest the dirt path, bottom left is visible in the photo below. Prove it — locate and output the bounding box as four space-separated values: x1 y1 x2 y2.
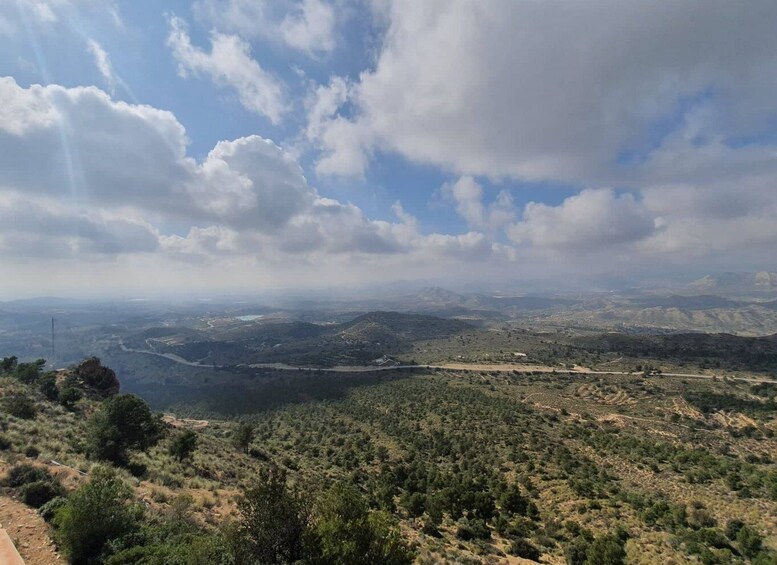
53 467 143 565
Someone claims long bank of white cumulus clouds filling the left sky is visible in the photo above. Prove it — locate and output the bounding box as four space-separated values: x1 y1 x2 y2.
0 78 504 290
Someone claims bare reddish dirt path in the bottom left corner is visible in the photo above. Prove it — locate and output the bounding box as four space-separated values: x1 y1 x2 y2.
0 496 66 565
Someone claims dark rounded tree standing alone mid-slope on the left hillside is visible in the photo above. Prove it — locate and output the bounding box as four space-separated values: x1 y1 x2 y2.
87 394 162 465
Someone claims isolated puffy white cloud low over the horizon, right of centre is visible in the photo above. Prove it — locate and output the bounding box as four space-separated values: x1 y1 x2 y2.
508 190 656 253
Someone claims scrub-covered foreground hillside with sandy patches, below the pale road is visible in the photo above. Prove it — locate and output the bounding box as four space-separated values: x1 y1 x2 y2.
0 350 777 565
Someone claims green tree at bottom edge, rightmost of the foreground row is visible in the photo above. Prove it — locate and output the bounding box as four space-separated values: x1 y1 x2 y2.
312 483 413 565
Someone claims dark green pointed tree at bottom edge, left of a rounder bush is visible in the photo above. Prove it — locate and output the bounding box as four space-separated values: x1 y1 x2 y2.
235 468 309 564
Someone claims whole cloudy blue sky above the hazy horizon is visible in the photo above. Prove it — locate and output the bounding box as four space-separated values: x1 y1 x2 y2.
0 0 777 299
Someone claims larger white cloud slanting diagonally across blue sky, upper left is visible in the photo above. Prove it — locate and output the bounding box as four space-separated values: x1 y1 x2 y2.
167 16 289 124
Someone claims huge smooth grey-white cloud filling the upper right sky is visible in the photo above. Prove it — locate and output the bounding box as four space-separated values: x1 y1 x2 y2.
310 0 777 184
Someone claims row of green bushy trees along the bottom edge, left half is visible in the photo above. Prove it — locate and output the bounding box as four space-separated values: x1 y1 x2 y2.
6 465 414 565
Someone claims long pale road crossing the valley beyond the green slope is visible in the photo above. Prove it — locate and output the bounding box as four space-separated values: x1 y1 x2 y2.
113 343 777 384
